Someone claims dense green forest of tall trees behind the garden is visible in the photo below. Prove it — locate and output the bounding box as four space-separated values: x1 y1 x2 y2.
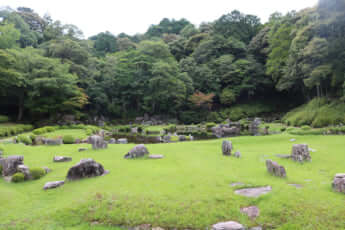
0 0 345 123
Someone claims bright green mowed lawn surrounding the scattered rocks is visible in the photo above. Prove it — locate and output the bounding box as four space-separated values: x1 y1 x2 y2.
0 135 345 230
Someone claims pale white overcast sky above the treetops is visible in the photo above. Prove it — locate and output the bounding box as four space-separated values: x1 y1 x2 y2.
0 0 317 37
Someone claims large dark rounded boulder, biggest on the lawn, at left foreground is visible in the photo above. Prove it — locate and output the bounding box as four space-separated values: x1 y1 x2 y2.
67 159 106 180
